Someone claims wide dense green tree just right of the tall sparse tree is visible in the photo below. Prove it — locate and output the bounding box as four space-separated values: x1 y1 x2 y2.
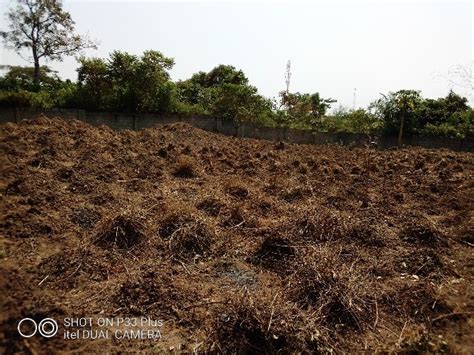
78 50 176 113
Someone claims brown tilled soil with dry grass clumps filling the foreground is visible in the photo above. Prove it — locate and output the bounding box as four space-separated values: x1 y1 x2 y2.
0 117 474 353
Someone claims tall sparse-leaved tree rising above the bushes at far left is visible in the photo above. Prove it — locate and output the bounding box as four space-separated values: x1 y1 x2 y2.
0 0 97 85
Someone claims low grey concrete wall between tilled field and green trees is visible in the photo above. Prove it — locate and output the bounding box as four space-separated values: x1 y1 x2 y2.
0 108 474 152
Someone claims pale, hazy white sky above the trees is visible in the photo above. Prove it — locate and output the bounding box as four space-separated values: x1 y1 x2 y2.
0 0 473 108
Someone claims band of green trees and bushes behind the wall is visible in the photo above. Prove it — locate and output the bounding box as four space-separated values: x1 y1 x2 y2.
0 50 474 138
